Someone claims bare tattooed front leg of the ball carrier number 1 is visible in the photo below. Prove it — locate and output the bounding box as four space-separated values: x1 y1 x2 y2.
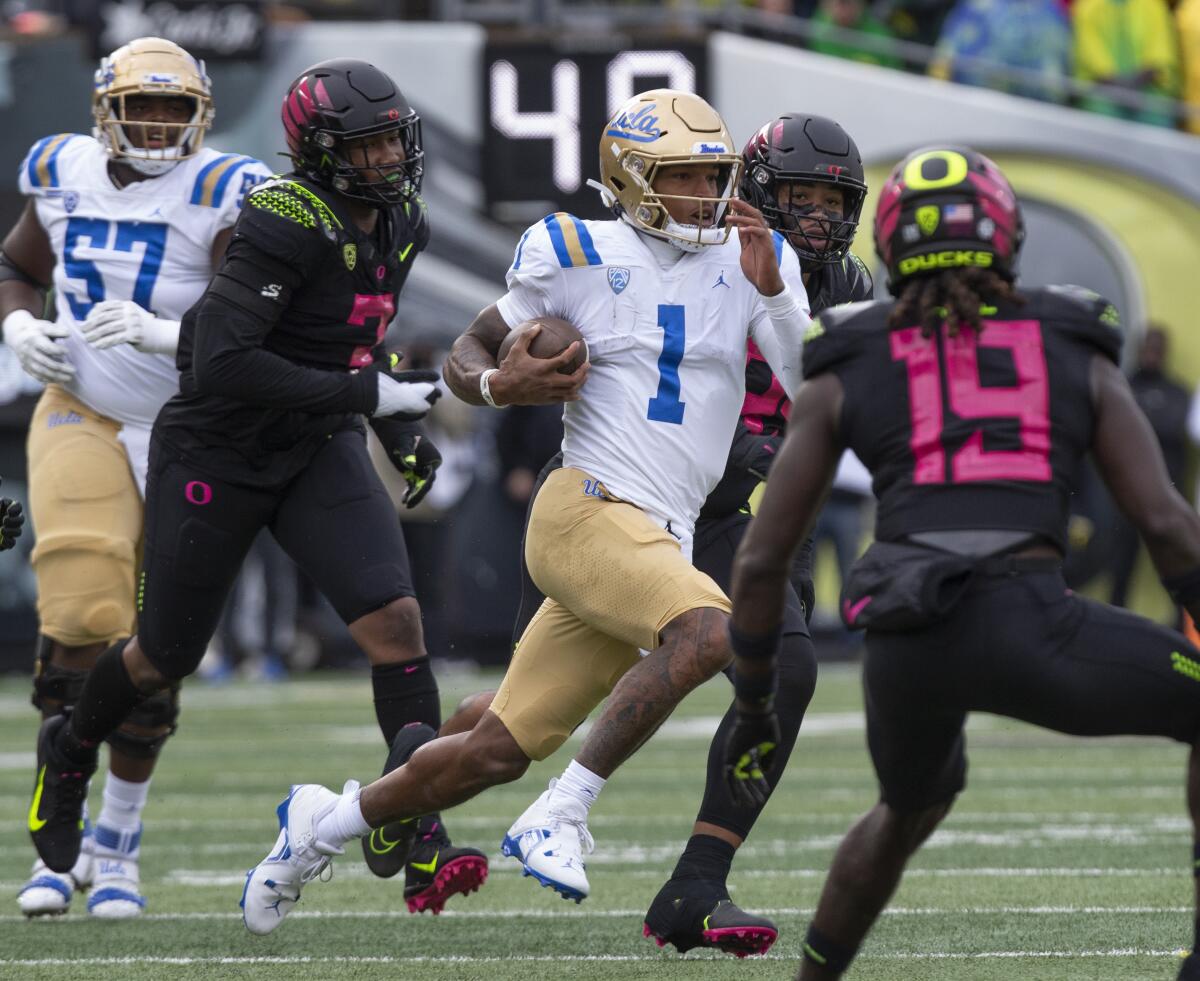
575 608 732 778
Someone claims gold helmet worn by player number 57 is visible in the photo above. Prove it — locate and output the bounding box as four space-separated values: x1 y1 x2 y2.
91 37 214 176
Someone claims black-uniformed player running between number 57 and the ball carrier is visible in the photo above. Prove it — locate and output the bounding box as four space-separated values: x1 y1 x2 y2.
19 59 487 920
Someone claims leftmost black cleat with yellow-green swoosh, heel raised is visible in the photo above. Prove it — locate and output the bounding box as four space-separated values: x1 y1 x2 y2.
29 715 96 873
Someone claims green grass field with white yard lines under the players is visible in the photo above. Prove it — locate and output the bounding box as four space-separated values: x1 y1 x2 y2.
0 666 1193 981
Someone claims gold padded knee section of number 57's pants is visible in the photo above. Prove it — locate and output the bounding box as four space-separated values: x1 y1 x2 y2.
32 532 134 646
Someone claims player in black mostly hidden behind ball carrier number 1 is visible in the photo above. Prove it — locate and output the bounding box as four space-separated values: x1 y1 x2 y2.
496 113 872 955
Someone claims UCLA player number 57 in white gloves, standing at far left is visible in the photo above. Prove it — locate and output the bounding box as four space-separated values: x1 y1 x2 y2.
0 37 269 917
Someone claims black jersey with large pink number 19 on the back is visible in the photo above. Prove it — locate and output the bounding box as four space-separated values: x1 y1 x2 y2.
804 287 1121 548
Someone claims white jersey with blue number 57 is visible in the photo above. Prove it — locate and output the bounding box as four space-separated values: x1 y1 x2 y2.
18 133 270 431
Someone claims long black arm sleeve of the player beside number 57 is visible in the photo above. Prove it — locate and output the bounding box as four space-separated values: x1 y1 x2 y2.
192 227 379 414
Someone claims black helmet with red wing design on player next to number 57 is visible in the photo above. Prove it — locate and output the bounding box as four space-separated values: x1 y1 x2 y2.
283 58 425 206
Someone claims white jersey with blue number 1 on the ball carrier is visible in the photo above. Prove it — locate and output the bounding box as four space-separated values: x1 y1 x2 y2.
497 213 808 542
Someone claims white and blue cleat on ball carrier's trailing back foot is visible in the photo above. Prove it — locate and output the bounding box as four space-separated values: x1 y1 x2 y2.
240 780 359 934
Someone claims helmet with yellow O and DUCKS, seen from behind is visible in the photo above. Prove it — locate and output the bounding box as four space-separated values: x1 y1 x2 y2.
875 146 1025 295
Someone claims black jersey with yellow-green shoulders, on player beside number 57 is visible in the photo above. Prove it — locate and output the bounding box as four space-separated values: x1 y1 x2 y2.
156 176 430 485
